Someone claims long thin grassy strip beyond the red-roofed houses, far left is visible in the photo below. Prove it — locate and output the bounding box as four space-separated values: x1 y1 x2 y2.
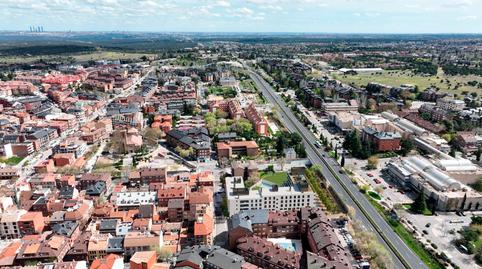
0 51 154 64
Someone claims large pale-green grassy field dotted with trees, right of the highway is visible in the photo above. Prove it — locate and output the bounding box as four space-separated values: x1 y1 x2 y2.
333 69 482 95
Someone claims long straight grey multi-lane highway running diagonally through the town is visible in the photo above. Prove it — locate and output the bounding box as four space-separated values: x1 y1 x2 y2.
250 72 428 269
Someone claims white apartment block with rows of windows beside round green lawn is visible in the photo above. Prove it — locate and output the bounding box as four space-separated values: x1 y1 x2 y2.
226 177 315 216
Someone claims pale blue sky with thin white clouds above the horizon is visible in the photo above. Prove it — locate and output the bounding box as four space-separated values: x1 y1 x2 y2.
0 0 482 33
